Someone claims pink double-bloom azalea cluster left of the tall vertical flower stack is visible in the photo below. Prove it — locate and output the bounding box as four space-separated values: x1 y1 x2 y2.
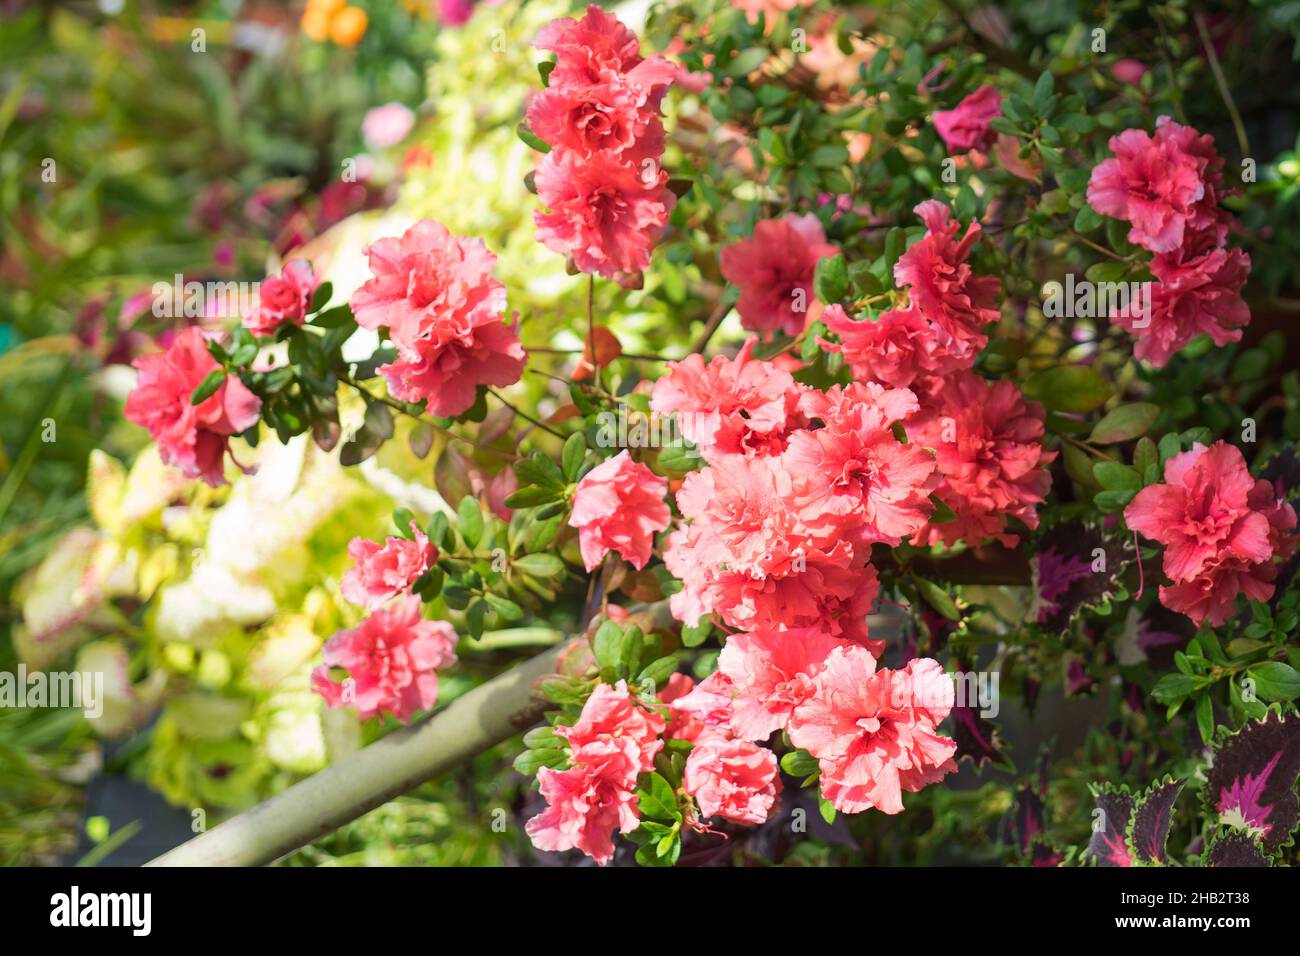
352 226 525 416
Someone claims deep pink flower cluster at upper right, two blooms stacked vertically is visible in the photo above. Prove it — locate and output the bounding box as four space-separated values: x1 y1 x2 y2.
1088 116 1251 367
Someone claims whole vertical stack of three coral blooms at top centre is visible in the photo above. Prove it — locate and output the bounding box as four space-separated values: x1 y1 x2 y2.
528 5 677 285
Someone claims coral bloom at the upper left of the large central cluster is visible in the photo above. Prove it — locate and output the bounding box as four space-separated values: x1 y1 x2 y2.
650 338 807 460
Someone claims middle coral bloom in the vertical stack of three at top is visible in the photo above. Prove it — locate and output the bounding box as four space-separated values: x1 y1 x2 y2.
527 79 664 158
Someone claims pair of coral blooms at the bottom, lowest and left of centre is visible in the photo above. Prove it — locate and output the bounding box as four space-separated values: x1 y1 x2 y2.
524 680 664 865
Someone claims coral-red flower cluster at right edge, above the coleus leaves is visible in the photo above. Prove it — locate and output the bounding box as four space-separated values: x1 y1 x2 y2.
1125 441 1296 627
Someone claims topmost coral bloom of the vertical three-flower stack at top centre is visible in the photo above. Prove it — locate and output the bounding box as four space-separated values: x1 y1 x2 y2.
533 4 677 109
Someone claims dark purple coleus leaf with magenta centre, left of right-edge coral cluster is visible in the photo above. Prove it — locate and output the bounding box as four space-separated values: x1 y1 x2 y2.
1030 522 1134 633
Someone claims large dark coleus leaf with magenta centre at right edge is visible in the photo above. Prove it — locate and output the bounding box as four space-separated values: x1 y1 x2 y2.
1201 709 1300 857
